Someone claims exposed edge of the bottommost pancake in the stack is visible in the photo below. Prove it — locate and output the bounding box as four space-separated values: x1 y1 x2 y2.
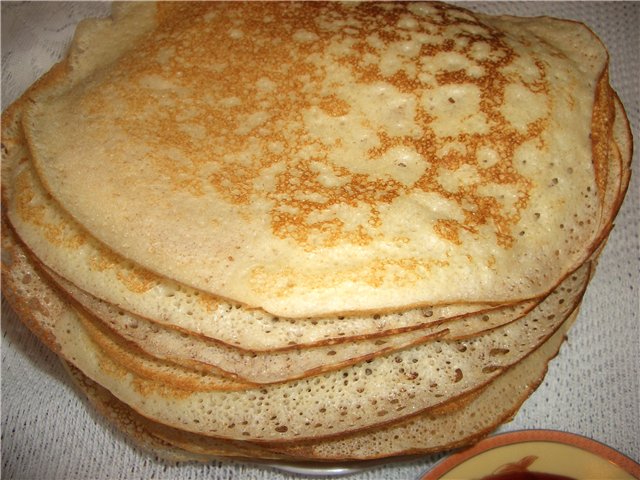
69 312 577 461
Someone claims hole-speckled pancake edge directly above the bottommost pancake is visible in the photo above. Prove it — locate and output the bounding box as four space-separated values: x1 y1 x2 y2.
3 212 590 442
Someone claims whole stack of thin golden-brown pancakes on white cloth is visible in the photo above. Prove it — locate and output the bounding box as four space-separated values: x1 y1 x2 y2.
2 2 631 461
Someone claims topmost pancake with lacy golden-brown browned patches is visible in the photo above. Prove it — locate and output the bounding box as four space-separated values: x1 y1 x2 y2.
25 2 611 317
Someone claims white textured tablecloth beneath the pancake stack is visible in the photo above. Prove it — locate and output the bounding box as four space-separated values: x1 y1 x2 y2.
1 2 640 480
